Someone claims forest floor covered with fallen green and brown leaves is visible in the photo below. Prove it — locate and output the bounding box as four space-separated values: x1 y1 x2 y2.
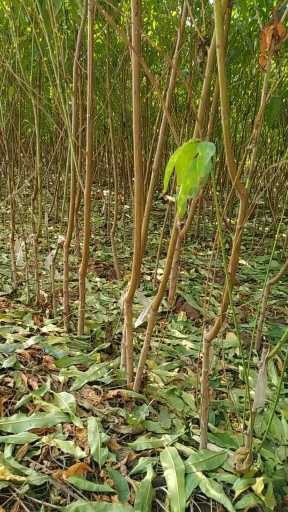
0 205 288 512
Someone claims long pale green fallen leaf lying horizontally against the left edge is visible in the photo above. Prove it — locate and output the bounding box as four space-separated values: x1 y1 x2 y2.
0 412 69 434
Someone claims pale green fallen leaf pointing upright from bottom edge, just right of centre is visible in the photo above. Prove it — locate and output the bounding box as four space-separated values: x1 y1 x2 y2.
160 446 186 512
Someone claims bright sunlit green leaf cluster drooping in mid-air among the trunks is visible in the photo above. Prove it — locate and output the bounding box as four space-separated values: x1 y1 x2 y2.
164 140 215 218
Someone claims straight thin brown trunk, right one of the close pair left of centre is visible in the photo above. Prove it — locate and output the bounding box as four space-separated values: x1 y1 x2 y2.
78 0 94 335
